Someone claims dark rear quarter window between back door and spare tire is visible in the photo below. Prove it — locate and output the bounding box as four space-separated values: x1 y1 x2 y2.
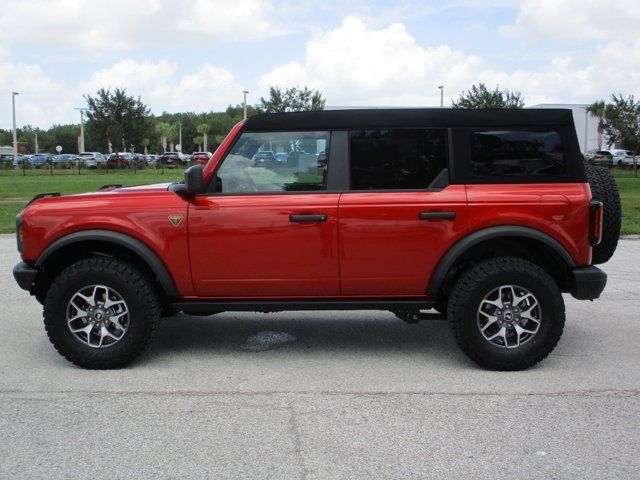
471 130 566 178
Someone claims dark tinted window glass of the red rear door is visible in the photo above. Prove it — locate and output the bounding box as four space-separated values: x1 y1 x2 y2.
349 129 447 190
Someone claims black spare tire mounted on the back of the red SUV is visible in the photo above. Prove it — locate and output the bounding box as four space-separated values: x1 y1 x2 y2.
585 165 620 265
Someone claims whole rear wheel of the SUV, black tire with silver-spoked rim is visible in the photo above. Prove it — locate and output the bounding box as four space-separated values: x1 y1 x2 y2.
448 257 565 370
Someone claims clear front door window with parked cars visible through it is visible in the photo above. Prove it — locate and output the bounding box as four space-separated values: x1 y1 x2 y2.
216 132 329 193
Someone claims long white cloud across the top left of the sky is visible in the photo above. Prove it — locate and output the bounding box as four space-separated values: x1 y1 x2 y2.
0 0 285 55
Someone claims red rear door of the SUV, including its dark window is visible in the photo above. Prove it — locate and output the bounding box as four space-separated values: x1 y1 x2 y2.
339 129 467 297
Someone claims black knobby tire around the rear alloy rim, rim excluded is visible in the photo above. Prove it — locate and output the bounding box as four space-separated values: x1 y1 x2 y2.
448 257 565 371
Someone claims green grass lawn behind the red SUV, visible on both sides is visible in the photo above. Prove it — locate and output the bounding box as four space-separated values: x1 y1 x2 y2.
0 168 640 235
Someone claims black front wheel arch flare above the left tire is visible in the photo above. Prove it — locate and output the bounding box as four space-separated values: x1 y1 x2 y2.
35 229 178 298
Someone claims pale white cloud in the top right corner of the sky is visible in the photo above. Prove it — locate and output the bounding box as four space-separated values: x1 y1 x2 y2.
501 0 640 42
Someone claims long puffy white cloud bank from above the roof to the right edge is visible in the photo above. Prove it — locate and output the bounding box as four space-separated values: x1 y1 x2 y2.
259 18 640 106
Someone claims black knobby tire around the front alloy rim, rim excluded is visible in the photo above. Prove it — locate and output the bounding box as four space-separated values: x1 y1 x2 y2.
43 257 160 369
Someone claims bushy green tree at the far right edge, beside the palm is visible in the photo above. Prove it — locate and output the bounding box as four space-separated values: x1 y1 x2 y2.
604 94 640 176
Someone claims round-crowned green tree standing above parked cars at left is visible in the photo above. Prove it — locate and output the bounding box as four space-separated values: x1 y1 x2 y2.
85 88 151 149
